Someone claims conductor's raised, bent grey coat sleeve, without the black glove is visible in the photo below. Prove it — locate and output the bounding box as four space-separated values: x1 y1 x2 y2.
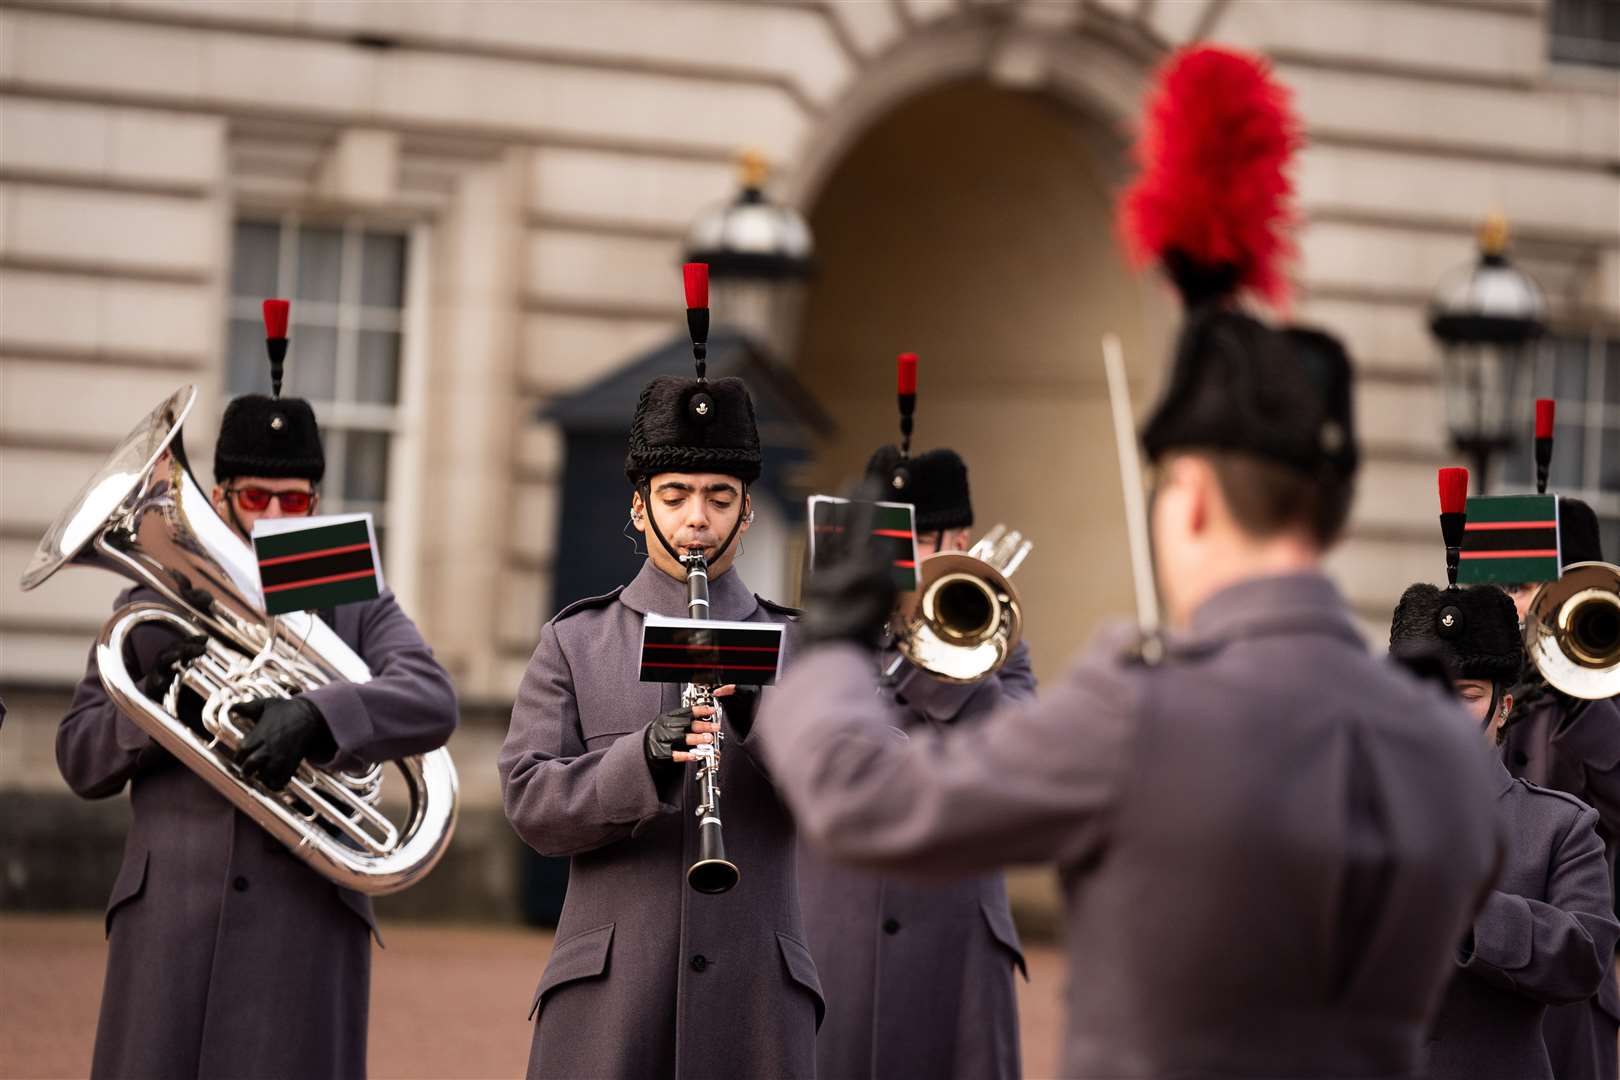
760 644 1136 874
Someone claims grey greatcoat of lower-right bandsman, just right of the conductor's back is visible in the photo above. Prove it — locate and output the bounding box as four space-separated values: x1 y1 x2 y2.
1429 766 1620 1080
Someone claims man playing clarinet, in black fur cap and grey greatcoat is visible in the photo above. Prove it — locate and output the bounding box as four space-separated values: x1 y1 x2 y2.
499 266 823 1080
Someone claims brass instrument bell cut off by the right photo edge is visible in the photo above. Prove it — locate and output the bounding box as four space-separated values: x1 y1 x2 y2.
1524 562 1620 699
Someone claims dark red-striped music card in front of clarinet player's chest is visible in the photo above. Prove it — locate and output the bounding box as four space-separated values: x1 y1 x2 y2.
642 615 782 687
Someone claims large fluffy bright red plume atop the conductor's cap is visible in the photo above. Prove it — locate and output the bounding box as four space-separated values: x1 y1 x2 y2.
1119 45 1304 308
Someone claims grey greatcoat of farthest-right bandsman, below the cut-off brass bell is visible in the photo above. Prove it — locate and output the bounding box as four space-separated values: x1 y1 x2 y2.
1502 693 1620 1080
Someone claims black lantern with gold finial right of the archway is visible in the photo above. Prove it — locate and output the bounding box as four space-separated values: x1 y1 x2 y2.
1429 214 1547 492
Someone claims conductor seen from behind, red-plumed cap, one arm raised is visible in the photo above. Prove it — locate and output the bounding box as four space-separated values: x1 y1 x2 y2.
760 49 1499 1080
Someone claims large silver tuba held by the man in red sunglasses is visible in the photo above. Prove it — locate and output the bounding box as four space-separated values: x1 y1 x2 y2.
21 385 457 895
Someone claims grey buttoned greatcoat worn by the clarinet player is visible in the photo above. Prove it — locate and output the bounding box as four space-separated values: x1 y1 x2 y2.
499 560 823 1080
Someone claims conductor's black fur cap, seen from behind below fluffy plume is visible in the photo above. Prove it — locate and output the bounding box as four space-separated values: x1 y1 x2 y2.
1142 308 1359 479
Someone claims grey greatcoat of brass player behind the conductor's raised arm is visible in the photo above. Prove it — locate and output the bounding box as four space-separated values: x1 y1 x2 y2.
799 643 1035 1080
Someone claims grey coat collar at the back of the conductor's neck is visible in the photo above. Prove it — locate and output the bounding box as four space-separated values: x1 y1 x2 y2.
1171 572 1366 653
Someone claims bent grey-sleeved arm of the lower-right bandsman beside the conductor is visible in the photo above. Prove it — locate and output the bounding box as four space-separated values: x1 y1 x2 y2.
1461 810 1620 1006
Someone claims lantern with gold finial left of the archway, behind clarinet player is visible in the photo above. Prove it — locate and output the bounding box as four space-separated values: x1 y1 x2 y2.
682 151 813 363
